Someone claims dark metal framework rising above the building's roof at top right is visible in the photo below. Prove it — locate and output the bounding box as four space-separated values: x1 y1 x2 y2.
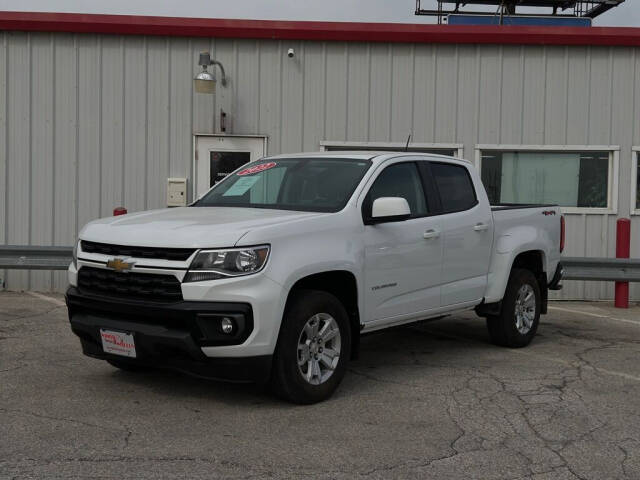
416 0 625 23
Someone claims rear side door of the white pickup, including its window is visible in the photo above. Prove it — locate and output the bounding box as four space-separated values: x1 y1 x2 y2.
429 161 493 306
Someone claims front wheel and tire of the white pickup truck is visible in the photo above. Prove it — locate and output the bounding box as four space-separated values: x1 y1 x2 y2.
271 290 351 404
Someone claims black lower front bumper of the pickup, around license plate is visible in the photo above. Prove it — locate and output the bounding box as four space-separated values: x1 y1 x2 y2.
66 287 272 383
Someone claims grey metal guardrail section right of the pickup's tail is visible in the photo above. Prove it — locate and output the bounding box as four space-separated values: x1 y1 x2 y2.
560 257 640 282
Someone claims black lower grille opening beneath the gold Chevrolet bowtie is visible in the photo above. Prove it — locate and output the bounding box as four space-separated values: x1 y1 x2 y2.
78 267 183 302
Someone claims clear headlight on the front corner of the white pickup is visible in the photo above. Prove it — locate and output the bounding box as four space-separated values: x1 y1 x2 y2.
183 245 269 282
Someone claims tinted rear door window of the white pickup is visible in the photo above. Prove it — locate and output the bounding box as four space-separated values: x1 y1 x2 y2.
431 163 478 213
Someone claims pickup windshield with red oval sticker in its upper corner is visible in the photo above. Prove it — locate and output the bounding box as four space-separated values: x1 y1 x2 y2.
195 157 371 212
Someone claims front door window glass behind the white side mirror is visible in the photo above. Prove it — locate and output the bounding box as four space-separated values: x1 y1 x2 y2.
364 163 428 217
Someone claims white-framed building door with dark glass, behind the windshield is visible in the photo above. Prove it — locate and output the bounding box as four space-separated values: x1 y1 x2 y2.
194 135 267 198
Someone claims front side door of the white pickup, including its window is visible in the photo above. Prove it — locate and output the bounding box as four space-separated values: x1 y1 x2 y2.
362 161 442 324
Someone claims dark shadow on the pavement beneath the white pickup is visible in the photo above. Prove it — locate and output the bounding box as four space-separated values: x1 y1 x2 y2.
102 319 516 407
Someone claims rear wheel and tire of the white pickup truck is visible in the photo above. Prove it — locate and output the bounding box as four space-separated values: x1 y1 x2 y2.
487 268 541 348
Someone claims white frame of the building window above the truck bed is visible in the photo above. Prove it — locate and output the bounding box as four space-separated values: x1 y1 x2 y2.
475 144 620 215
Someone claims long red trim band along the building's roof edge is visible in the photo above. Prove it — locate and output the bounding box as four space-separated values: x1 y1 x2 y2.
0 12 640 46
